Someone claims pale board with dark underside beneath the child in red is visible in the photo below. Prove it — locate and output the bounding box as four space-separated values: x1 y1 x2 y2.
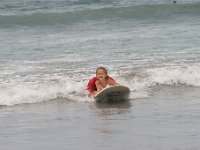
94 85 130 102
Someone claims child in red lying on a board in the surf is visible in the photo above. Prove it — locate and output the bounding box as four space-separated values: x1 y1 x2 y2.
87 67 118 97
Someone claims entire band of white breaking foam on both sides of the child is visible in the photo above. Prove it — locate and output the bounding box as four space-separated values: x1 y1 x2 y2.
0 65 200 106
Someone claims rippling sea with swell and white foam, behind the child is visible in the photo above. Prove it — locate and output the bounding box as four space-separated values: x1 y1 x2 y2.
0 0 200 106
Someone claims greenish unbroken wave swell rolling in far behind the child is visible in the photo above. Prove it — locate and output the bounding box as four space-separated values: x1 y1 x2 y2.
0 3 200 26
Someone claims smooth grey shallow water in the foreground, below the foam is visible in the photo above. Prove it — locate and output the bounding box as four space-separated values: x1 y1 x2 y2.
0 87 200 150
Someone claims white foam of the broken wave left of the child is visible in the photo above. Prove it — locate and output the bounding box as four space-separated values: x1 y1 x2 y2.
0 75 89 106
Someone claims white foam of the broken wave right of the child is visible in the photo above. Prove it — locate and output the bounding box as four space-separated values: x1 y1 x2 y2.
118 65 200 98
